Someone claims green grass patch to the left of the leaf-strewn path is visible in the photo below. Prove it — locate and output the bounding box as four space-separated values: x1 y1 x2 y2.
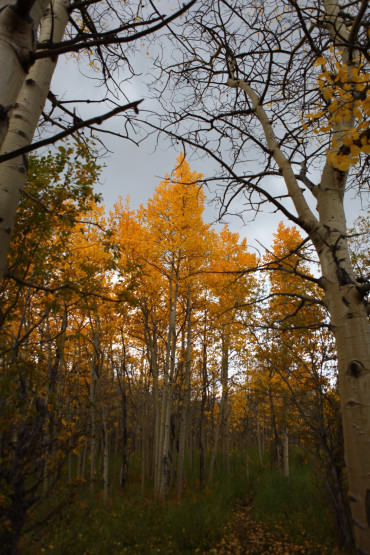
23 470 247 555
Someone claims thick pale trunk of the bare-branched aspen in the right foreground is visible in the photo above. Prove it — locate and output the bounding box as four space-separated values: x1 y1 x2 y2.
318 170 370 553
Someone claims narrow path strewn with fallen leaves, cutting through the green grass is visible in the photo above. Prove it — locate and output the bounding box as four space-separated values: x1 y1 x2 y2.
209 502 344 555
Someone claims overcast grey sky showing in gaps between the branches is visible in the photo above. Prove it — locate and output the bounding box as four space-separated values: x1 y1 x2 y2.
51 25 361 253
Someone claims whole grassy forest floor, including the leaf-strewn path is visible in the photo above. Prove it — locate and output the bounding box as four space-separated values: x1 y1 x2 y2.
24 463 354 555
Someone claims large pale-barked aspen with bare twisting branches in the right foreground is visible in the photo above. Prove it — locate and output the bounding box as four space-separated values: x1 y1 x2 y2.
150 0 370 553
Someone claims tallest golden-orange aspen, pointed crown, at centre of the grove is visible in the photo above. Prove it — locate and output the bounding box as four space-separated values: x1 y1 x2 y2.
114 155 209 497
